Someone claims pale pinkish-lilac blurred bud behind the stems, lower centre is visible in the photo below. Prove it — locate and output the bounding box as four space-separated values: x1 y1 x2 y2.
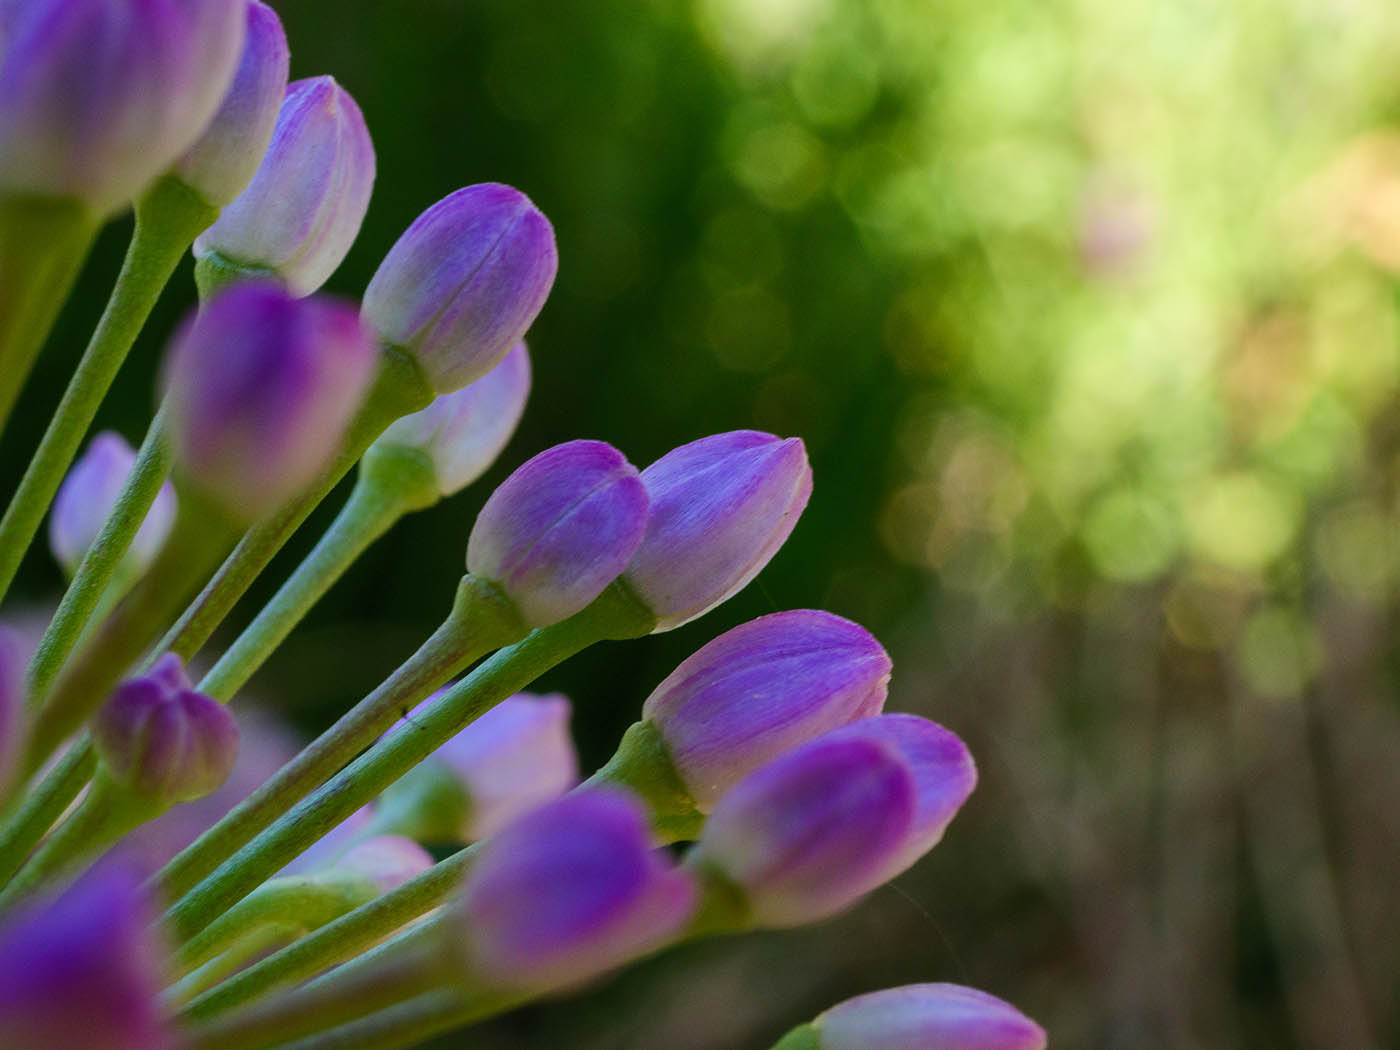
374 693 578 843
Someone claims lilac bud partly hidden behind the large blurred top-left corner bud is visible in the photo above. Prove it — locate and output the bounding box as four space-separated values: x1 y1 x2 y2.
175 0 290 207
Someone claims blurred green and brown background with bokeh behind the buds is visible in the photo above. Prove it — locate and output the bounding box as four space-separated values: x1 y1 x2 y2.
0 0 1400 1050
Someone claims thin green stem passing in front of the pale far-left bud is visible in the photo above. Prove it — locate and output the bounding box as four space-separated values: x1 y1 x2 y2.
28 410 171 708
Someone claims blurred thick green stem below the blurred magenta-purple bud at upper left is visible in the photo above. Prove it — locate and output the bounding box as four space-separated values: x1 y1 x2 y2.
25 490 237 777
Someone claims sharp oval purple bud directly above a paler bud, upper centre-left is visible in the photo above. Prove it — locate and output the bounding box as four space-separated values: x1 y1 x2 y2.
364 182 559 393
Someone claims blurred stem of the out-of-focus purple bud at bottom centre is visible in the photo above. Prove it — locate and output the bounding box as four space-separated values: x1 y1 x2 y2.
185 924 448 1050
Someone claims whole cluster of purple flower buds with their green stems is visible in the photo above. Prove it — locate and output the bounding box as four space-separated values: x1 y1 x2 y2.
0 0 1044 1050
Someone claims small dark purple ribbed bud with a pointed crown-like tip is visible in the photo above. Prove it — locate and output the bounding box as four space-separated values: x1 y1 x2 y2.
92 652 238 805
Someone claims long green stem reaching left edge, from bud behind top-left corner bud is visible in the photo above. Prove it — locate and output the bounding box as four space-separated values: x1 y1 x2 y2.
0 176 218 599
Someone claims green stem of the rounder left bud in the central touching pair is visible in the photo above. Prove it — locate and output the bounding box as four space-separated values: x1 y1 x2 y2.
155 577 525 907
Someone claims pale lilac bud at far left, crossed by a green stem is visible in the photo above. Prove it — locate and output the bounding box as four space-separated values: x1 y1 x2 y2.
49 430 175 578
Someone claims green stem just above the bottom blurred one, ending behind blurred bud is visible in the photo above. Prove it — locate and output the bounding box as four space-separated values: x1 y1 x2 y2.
181 844 477 1021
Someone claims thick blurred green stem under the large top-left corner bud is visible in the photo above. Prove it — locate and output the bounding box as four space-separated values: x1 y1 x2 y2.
0 196 99 439
